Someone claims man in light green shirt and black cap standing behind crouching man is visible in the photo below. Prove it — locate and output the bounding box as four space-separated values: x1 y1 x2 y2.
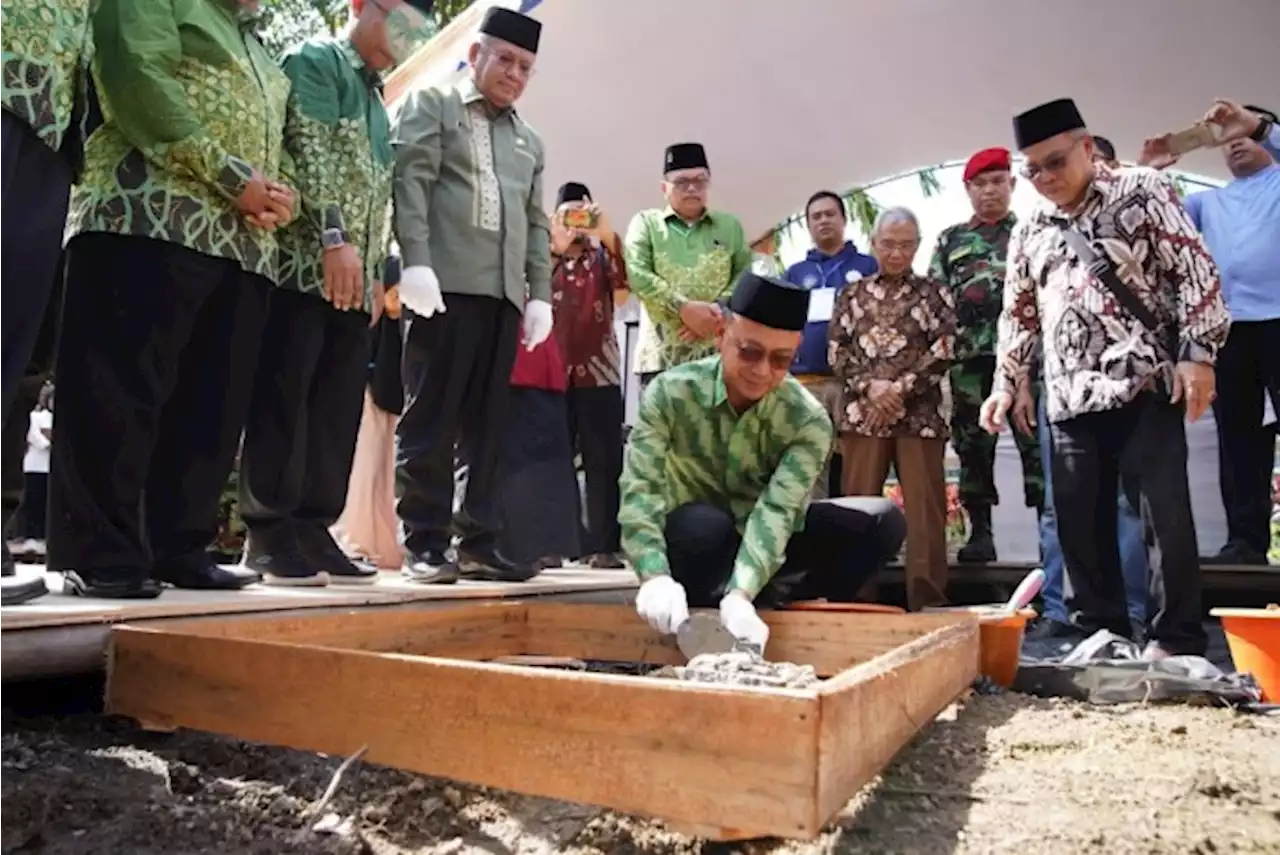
625 142 751 384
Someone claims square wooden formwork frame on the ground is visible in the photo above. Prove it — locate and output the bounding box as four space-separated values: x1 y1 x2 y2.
106 603 978 840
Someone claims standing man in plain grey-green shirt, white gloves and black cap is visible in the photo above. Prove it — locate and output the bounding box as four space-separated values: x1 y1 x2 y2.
392 6 552 584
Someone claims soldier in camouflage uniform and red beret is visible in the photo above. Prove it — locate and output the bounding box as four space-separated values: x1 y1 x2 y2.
929 148 1044 563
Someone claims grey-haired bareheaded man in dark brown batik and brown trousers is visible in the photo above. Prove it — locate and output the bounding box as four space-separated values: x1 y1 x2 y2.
828 207 956 609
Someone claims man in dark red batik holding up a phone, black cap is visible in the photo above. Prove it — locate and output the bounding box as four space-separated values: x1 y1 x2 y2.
552 182 630 567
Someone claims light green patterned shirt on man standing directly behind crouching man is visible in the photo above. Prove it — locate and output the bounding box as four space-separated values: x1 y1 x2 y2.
626 207 751 374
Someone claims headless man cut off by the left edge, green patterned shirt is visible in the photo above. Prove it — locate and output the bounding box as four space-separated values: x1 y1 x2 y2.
0 0 91 605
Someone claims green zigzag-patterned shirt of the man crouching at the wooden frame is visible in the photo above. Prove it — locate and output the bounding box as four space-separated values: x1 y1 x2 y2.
618 356 835 598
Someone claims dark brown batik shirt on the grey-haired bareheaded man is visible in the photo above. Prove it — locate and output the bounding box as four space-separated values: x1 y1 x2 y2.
828 273 956 439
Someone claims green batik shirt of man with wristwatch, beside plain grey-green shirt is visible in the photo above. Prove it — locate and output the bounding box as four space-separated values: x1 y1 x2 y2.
279 40 393 308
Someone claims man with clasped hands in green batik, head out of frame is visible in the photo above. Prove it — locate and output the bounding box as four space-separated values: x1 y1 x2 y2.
49 0 296 598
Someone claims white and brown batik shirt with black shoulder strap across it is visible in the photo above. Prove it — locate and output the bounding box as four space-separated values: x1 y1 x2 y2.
996 165 1230 422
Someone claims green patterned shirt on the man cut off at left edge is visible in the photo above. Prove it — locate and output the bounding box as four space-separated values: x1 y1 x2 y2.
0 0 92 151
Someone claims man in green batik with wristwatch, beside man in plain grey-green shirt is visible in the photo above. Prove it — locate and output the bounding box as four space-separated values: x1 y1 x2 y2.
239 0 431 586
